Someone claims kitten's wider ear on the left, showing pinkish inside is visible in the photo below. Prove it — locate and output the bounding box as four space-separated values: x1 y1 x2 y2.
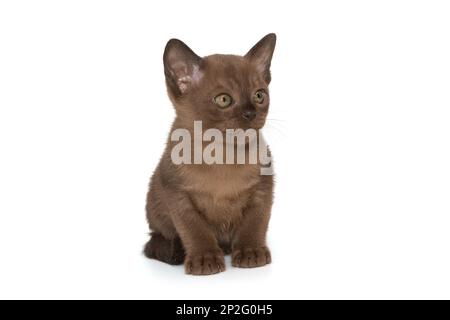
163 39 202 96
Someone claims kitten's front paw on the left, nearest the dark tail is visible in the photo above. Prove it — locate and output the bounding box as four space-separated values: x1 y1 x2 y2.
184 251 225 275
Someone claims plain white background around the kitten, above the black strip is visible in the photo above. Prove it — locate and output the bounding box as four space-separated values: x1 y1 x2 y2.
0 0 450 299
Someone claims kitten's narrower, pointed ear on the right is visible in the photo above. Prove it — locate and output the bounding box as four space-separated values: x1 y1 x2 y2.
245 33 277 83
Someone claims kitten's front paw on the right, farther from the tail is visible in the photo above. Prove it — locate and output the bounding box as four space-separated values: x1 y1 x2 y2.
231 247 272 268
